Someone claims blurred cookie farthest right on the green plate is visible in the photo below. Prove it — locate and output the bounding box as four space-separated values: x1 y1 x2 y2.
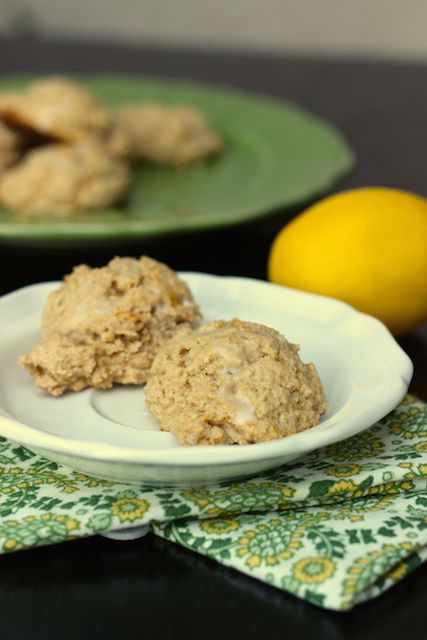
117 103 223 167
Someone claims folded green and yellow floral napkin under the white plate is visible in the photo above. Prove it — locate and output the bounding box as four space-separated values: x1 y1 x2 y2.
0 396 427 610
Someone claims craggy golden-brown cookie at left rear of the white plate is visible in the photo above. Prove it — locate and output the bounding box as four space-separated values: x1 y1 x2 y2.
20 256 200 396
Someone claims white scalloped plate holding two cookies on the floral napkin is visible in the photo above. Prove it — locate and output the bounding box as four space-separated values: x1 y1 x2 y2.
0 273 413 485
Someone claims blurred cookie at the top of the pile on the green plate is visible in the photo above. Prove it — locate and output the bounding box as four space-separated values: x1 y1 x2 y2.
0 76 112 142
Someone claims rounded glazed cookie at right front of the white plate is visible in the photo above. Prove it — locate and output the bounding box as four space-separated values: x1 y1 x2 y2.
145 319 327 445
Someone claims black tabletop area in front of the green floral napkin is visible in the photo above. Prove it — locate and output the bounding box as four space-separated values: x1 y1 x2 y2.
0 535 427 640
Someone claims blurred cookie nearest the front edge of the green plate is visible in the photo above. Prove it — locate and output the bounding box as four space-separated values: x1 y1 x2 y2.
0 144 131 216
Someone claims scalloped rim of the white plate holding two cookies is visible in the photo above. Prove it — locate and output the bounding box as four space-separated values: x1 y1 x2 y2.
0 272 413 467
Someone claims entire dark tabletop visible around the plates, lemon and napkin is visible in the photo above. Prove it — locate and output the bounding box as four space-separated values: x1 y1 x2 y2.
0 39 427 640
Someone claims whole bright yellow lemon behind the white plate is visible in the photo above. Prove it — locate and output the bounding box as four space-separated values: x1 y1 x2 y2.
268 187 427 335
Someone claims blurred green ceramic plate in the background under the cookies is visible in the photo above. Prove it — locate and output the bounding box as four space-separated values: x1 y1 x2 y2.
0 76 354 241
